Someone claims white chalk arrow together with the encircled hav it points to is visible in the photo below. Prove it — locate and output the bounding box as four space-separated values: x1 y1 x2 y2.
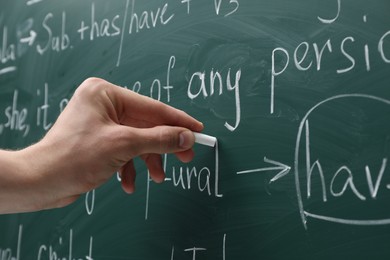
237 94 390 228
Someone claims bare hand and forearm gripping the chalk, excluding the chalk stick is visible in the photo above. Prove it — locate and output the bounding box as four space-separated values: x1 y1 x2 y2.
0 78 203 214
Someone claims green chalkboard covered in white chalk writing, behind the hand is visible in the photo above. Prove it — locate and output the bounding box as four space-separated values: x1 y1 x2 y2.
0 0 390 260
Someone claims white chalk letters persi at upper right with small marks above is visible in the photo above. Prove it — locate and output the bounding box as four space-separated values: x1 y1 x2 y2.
270 0 390 114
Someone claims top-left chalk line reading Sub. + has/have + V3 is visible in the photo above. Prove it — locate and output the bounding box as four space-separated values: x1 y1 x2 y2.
0 0 239 69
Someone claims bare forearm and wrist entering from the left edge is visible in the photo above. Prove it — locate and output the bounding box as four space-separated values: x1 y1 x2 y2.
0 142 79 214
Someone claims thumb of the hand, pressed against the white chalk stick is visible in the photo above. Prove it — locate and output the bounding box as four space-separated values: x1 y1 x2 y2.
129 126 195 155
